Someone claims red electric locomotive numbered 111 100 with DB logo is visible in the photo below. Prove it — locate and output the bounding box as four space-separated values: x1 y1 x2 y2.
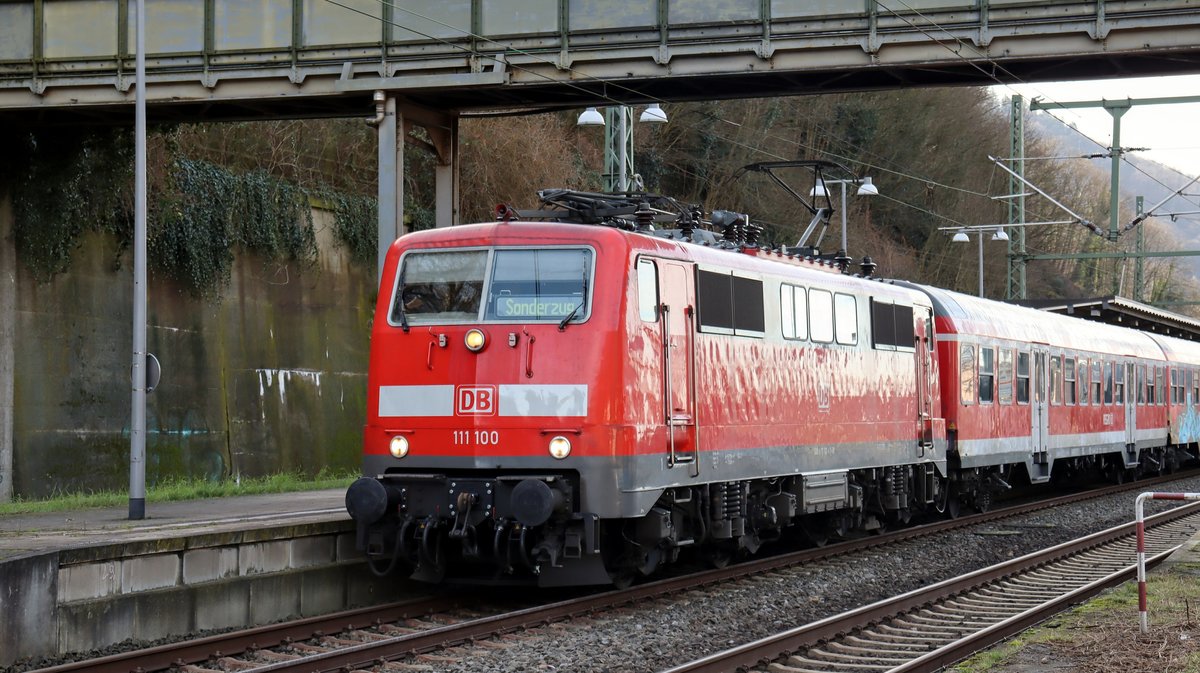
347 187 949 585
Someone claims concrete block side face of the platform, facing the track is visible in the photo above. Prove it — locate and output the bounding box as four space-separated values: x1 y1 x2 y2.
0 521 413 666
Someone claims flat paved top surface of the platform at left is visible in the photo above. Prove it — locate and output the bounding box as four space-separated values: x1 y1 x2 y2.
0 488 349 560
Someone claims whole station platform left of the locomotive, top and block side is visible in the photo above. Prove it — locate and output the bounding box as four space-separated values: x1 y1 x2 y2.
0 487 403 668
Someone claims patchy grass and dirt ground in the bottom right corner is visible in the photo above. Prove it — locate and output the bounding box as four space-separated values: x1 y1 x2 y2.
950 564 1200 673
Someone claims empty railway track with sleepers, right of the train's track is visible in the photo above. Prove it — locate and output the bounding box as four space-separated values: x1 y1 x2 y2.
667 504 1200 673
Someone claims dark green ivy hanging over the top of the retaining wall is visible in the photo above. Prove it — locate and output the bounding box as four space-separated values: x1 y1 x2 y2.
0 130 377 296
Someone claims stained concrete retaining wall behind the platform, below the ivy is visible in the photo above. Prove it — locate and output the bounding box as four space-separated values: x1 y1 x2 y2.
0 194 376 501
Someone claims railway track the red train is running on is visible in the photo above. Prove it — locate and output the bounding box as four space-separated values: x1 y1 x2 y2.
36 475 1200 673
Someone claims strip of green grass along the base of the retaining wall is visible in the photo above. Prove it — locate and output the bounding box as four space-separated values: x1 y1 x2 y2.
0 470 359 516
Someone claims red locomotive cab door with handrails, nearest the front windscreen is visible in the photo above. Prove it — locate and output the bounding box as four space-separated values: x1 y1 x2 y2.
655 259 700 474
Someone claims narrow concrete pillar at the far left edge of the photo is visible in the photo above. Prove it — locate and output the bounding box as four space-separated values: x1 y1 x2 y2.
0 185 17 503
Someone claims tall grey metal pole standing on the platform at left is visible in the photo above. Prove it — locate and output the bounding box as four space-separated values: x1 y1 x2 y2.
130 0 146 519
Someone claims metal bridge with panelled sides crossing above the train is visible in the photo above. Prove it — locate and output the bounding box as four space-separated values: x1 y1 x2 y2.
0 0 1200 122
